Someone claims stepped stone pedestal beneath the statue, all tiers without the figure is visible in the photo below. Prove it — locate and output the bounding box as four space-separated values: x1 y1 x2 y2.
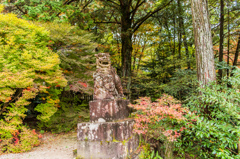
77 99 139 159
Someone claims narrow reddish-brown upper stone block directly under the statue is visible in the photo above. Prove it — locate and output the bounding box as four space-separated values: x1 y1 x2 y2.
89 99 129 122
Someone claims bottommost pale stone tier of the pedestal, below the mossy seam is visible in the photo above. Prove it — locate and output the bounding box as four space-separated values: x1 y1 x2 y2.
77 136 139 159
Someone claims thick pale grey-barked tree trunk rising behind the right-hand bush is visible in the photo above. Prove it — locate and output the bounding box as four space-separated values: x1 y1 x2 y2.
191 0 216 87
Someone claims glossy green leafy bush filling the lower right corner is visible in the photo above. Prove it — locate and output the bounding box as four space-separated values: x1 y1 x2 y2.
176 69 240 159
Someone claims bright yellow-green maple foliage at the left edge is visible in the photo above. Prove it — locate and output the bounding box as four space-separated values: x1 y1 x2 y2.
0 6 67 154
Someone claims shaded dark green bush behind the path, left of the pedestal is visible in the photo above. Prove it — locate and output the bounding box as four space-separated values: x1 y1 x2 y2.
38 91 89 133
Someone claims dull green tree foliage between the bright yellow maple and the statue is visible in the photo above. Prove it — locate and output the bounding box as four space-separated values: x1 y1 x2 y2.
35 22 96 94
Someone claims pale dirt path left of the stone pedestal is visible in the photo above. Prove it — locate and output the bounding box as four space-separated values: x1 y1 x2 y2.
0 132 77 159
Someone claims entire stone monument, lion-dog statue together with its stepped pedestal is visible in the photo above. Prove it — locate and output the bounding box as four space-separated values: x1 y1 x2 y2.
77 53 139 159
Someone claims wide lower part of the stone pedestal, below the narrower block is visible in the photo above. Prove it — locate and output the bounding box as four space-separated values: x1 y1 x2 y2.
77 119 139 159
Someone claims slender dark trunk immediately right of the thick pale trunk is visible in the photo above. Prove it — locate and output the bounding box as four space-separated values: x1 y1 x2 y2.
218 0 224 80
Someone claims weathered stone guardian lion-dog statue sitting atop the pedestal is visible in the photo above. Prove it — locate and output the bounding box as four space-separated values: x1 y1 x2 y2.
93 53 124 100
